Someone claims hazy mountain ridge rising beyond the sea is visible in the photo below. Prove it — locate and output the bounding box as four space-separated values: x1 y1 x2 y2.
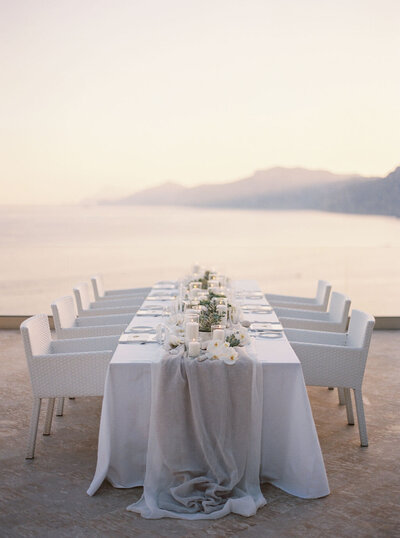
103 167 400 216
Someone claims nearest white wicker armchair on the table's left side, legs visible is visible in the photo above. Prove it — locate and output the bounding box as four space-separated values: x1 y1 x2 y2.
21 314 118 459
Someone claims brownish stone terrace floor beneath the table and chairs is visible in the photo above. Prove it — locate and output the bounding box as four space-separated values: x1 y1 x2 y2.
0 331 400 538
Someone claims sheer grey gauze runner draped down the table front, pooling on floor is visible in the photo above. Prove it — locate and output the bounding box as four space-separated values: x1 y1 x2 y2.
128 349 266 519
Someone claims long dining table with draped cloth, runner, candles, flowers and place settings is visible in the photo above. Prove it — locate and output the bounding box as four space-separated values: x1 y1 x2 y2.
88 265 329 519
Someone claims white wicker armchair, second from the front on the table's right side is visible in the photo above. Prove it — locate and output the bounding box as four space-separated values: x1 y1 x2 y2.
275 292 351 332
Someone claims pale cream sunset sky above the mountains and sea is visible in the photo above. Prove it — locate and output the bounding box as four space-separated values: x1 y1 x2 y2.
0 0 400 204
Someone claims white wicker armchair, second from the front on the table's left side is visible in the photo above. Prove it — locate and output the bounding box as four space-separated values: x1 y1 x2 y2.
51 297 132 338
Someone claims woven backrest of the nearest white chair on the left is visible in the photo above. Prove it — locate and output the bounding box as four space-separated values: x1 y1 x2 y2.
20 314 51 358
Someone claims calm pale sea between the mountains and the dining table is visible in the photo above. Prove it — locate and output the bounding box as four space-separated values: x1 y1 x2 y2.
0 206 400 315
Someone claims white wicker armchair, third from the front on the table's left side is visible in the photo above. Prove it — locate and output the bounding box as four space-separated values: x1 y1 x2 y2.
74 282 143 317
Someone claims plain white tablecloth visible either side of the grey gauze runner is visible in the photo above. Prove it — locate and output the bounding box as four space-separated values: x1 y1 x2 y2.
87 281 329 499
